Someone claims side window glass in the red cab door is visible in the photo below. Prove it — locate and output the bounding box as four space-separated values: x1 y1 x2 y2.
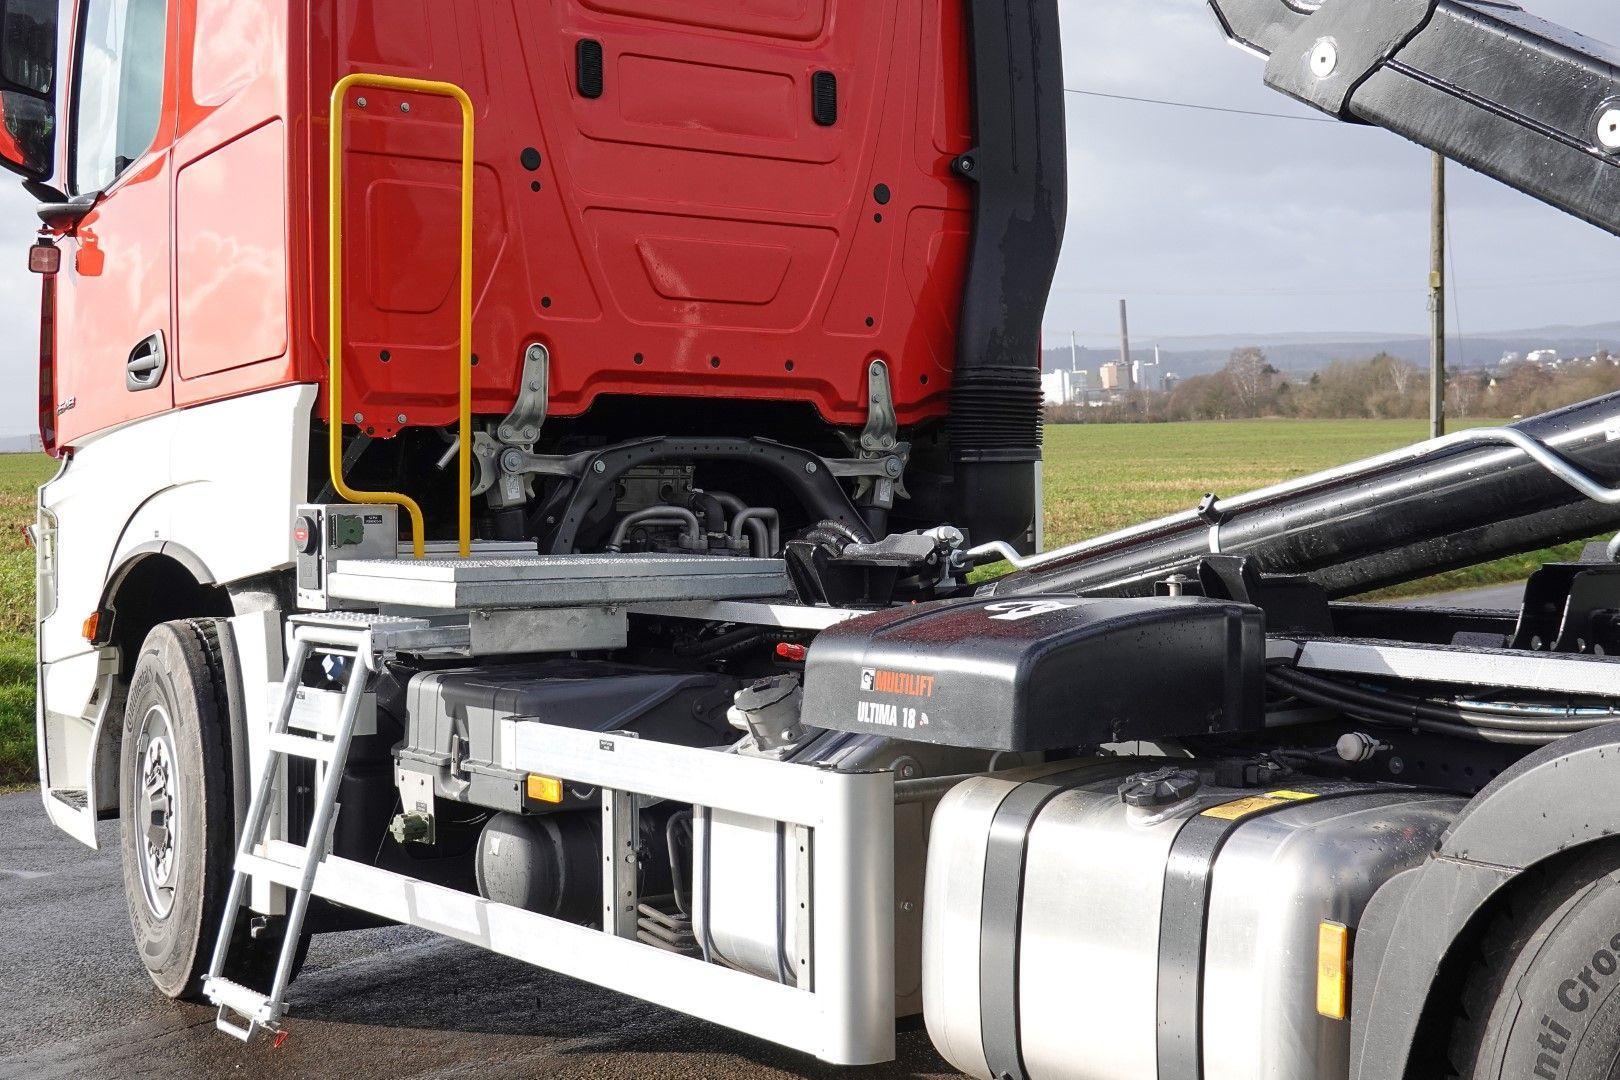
73 0 168 194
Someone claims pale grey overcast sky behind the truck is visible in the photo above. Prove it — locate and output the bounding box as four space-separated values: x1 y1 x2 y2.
0 0 1620 436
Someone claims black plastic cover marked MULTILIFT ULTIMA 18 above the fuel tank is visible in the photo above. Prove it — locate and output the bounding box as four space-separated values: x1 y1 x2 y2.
804 596 1265 751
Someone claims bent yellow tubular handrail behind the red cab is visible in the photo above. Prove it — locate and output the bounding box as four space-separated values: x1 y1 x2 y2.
327 71 473 559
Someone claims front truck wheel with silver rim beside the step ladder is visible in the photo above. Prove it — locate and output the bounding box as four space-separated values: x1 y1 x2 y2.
118 619 308 999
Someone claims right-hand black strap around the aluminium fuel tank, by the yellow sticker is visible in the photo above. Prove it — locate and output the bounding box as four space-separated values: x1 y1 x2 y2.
1158 782 1369 1080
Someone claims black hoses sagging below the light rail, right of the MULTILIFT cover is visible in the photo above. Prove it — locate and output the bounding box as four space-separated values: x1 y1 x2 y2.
1265 667 1620 746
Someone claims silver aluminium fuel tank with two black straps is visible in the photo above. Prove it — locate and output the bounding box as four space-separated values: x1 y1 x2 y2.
923 759 1464 1080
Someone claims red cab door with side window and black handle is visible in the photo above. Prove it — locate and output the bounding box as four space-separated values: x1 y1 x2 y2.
55 0 177 445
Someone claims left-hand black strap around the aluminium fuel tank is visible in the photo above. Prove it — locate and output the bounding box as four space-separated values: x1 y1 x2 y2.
978 759 1142 1080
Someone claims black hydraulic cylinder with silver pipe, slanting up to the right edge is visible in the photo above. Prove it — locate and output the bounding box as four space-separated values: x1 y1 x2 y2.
988 393 1620 597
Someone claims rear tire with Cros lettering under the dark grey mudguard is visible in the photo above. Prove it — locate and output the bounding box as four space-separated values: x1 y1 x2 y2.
1450 844 1620 1080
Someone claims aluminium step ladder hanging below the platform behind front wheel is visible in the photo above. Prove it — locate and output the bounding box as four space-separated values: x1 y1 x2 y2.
203 612 468 1041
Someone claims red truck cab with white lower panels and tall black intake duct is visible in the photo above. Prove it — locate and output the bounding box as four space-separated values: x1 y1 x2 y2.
12 0 1064 837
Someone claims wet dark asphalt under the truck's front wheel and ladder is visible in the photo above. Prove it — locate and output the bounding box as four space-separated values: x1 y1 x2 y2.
0 792 957 1080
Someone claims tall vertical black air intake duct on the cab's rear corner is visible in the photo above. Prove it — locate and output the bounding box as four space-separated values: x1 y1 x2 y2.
948 0 1068 549
